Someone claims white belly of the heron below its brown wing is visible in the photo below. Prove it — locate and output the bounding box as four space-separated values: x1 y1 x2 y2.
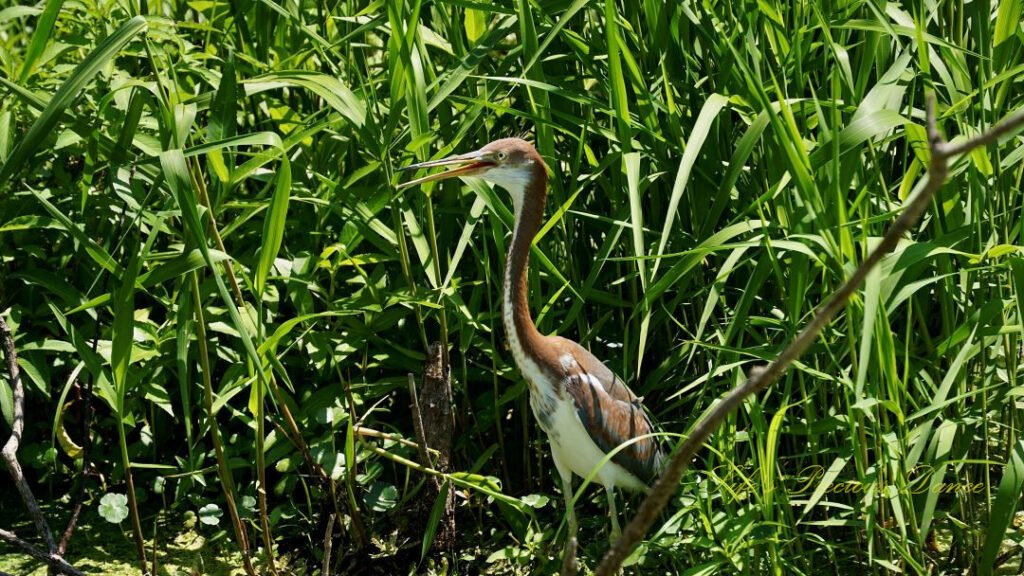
530 394 646 490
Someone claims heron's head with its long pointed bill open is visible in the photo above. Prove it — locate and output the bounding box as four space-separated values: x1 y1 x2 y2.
398 138 547 202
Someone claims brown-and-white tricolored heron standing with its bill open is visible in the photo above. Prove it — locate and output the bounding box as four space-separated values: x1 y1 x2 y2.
399 138 663 540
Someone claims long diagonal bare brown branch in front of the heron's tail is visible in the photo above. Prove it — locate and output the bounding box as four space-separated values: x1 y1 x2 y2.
595 94 1024 576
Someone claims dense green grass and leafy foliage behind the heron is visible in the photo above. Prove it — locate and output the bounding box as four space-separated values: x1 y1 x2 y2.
0 0 1024 574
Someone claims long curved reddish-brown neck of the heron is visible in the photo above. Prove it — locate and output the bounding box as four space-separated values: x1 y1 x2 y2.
502 164 548 354
